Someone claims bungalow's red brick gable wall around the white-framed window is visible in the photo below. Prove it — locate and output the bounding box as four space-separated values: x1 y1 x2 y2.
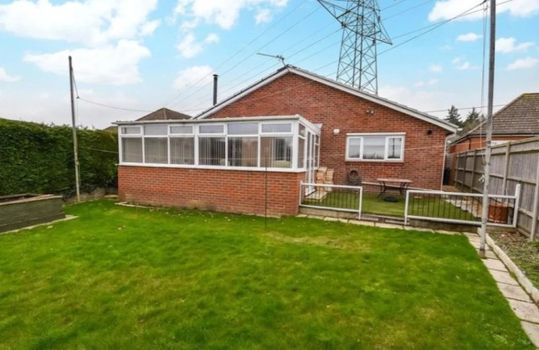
210 73 446 189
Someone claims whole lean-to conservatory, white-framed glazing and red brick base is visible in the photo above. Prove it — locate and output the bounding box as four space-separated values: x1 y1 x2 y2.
116 115 320 215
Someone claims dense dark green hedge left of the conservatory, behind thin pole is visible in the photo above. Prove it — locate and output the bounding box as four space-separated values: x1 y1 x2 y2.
0 119 118 196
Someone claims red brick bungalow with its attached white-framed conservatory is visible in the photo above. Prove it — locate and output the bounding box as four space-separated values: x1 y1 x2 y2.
117 66 456 215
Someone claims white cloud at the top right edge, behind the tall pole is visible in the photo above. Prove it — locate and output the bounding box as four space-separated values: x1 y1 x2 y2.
428 0 539 22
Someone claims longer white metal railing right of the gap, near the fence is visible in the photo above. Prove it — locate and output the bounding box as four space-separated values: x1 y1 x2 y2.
404 185 520 227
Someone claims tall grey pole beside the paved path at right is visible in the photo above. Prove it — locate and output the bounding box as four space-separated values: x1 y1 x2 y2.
479 0 496 258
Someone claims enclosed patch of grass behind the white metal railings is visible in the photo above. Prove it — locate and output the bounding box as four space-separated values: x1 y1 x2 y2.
304 191 474 220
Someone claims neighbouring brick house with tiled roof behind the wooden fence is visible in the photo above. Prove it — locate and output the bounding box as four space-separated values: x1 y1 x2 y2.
449 92 539 154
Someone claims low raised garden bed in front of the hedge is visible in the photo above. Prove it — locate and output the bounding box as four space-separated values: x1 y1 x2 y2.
0 194 65 232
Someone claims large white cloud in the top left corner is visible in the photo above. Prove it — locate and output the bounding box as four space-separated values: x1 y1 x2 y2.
0 0 159 46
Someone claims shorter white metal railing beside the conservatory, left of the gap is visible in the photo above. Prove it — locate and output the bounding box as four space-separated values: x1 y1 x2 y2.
299 182 363 219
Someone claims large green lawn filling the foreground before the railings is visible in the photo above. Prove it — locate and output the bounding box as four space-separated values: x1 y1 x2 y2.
0 201 532 349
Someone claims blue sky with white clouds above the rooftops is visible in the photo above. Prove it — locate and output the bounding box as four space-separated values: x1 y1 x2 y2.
0 0 539 128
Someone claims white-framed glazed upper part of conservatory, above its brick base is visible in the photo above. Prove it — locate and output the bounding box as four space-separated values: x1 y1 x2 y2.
116 116 320 174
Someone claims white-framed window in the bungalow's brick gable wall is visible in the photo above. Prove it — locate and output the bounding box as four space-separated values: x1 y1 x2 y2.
346 134 404 161
